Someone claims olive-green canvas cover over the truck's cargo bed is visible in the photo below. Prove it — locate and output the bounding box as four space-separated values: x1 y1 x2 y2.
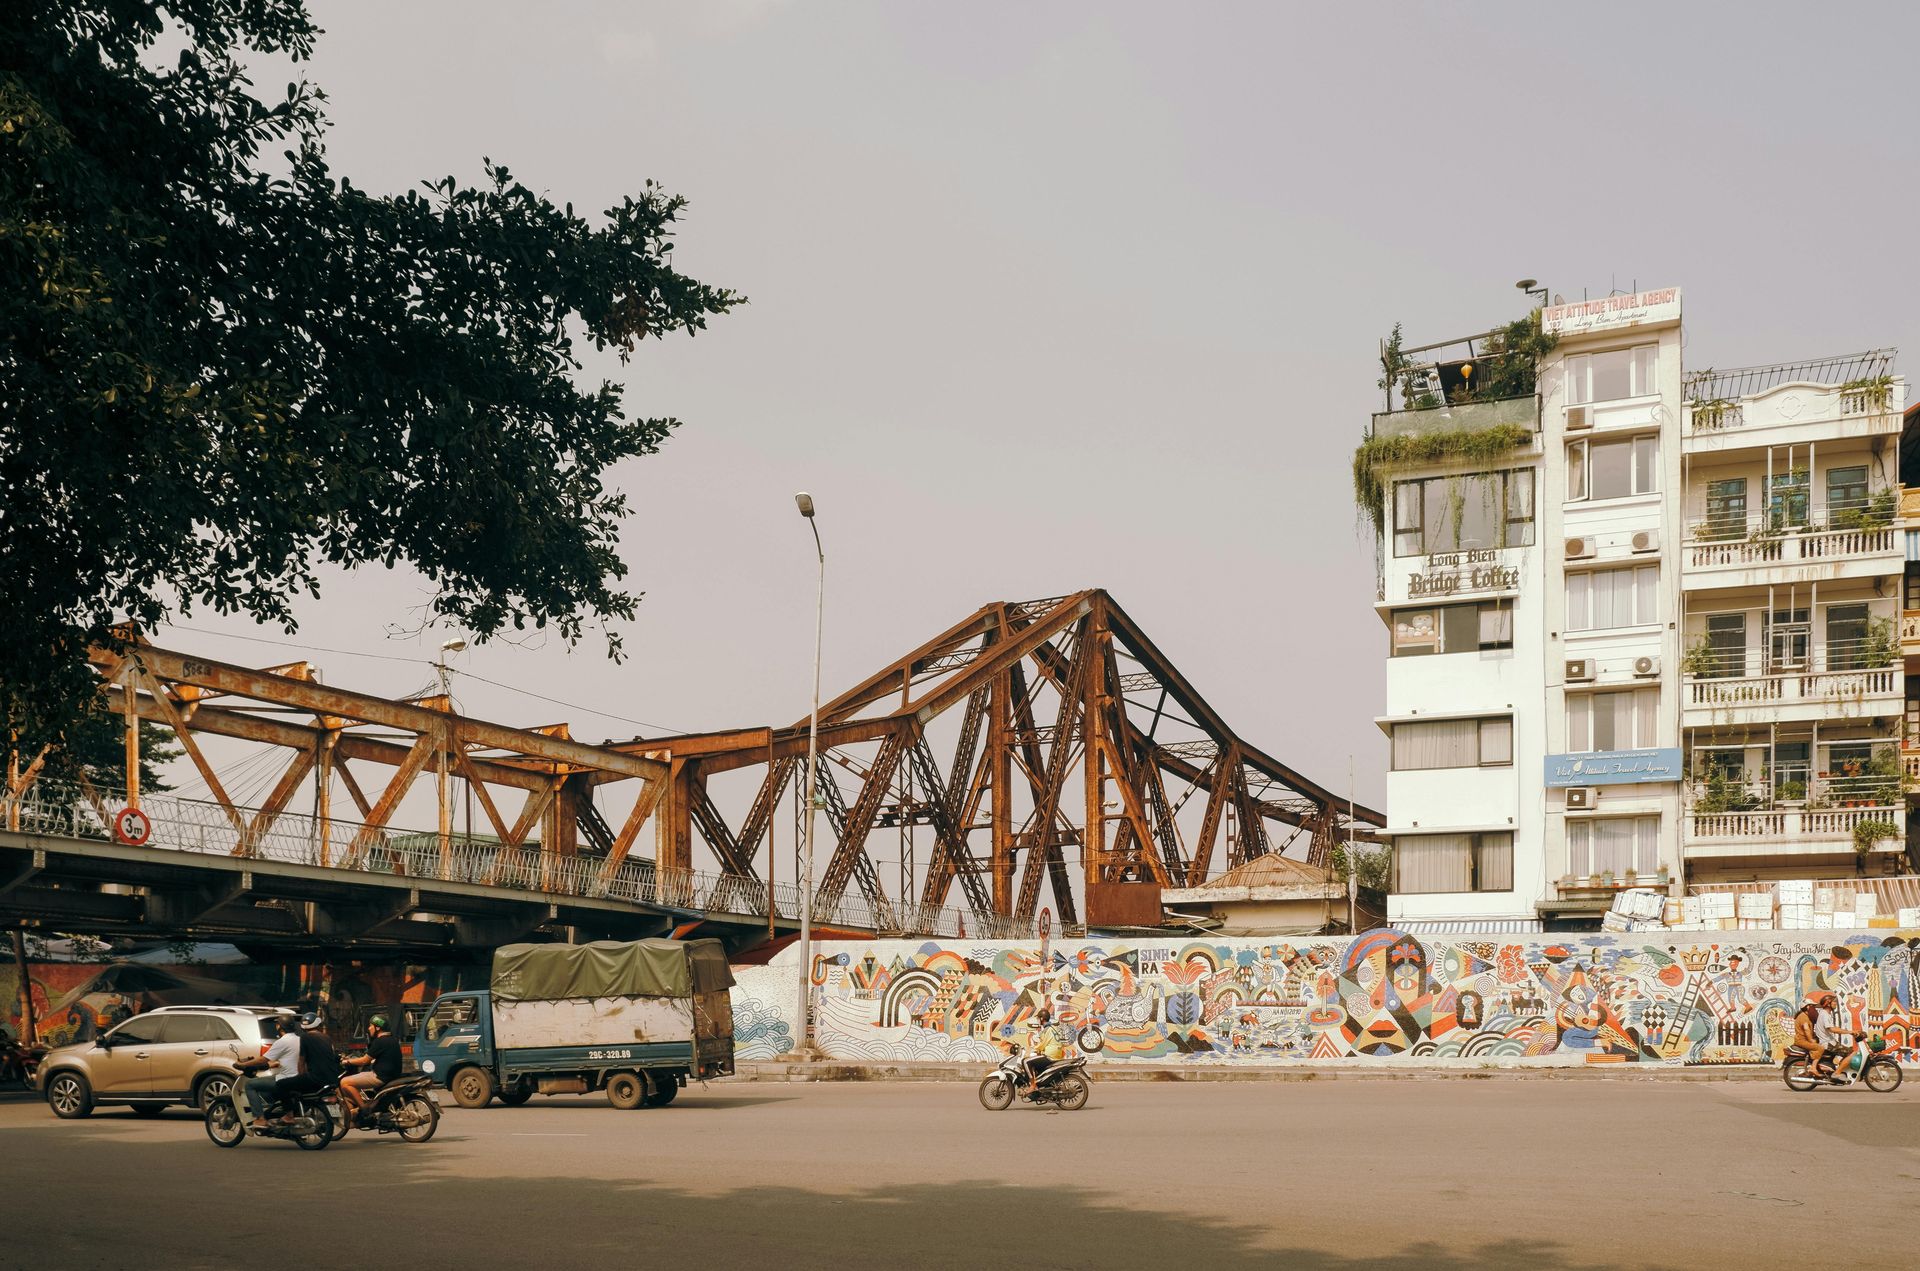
493 941 733 1002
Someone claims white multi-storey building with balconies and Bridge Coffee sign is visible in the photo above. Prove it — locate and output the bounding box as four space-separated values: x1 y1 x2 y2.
1363 288 1905 929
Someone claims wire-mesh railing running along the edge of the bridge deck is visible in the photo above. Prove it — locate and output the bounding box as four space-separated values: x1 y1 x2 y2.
0 781 1033 939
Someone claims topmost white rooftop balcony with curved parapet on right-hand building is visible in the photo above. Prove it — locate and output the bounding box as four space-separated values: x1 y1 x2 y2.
1682 349 1907 455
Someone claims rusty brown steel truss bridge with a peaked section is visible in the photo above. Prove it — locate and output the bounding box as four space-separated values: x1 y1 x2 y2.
0 591 1382 954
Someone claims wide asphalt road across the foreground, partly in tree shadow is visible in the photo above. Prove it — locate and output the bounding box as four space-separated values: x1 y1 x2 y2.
0 1077 1920 1271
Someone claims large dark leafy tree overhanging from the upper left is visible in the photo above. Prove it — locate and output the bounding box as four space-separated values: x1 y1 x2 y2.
0 0 743 752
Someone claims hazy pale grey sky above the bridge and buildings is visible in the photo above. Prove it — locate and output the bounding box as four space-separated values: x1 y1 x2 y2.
165 0 1920 825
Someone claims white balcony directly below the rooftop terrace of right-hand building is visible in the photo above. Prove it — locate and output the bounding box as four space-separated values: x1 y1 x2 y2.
1680 509 1905 588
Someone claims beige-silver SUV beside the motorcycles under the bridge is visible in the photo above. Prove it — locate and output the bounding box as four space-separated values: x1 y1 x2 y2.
35 1006 292 1119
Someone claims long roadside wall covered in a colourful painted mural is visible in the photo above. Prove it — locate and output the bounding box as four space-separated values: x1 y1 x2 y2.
733 927 1920 1064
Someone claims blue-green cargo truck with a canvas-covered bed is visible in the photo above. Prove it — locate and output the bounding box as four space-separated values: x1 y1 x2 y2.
413 941 733 1108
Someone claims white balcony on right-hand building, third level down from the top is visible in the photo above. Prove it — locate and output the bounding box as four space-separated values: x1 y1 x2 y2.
1682 641 1907 728
